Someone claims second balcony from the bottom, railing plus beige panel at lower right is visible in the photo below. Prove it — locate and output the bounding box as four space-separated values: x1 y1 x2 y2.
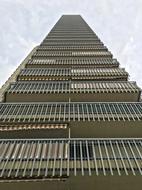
0 102 142 138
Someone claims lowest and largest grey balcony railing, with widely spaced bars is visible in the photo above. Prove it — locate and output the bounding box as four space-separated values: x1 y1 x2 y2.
0 139 142 180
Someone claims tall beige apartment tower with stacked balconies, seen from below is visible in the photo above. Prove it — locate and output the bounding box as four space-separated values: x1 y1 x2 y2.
0 15 142 190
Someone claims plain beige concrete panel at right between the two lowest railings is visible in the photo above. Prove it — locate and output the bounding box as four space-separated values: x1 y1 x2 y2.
70 121 142 138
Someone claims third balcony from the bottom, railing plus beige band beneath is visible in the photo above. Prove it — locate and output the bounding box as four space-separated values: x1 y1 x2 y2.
5 81 141 102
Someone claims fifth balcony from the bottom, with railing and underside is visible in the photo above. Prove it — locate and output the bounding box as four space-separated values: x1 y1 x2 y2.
26 57 119 68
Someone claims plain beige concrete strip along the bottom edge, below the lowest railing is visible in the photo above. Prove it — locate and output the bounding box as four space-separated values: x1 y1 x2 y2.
0 176 142 190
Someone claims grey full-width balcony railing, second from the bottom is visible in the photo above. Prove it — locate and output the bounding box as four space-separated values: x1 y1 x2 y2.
0 102 142 123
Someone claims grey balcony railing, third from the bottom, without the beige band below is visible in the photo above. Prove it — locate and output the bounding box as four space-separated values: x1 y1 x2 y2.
6 81 140 93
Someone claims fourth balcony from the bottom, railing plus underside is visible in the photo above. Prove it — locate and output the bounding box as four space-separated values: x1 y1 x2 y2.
18 66 128 81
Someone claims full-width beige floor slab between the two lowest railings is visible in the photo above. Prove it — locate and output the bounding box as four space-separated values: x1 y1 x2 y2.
0 121 142 139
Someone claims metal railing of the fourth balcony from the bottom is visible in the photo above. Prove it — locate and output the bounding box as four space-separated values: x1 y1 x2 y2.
19 67 128 79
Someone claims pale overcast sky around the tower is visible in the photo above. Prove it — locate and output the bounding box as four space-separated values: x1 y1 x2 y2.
0 0 142 87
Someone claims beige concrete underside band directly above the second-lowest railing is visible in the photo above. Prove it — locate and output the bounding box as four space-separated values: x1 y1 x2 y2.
5 92 139 102
